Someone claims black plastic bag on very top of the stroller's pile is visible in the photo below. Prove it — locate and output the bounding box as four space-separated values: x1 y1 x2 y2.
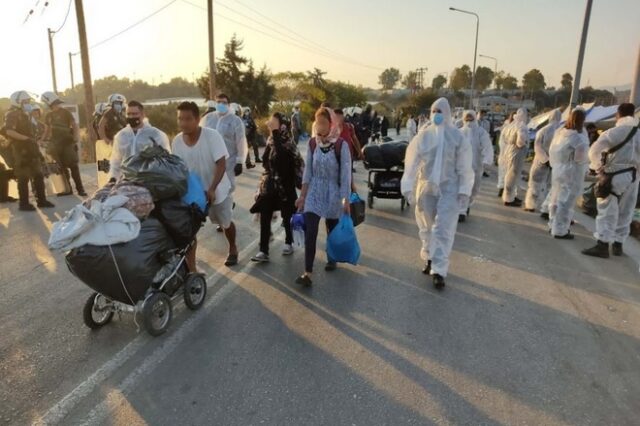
122 145 189 201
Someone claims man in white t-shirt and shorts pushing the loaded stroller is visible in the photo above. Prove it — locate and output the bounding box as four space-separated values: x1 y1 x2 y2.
172 102 238 272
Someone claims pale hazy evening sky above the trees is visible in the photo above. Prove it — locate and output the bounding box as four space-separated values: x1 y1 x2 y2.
0 0 640 97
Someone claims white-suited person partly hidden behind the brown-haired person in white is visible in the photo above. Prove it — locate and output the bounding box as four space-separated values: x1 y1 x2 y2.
524 109 562 213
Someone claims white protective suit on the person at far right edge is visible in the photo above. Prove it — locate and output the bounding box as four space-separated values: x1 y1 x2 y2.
589 117 640 244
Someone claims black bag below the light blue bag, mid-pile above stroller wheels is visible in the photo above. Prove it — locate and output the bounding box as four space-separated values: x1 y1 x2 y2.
151 198 206 247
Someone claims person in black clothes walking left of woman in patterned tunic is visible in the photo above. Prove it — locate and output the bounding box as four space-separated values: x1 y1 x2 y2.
251 112 299 262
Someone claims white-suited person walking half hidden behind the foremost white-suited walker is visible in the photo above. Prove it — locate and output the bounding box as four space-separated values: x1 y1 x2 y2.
458 110 493 222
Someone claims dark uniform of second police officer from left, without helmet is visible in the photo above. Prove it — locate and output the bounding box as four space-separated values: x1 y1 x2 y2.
44 107 84 194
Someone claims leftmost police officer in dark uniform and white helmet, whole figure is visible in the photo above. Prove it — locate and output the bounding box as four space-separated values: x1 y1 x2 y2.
5 90 54 211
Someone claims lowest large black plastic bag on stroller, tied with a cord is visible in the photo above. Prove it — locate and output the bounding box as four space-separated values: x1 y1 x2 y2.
66 218 175 304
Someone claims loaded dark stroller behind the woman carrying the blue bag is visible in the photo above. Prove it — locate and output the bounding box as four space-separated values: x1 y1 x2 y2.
364 141 409 211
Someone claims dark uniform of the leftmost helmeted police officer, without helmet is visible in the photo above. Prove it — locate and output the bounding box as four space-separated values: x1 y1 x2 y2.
5 108 47 207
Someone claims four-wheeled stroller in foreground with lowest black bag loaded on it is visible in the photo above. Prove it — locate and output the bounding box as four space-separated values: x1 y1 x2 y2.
66 205 207 336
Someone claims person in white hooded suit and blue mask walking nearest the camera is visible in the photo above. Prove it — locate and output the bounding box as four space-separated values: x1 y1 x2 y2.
401 98 474 290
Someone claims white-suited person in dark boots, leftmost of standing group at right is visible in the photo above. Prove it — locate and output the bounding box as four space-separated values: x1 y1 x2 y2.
502 108 529 207
